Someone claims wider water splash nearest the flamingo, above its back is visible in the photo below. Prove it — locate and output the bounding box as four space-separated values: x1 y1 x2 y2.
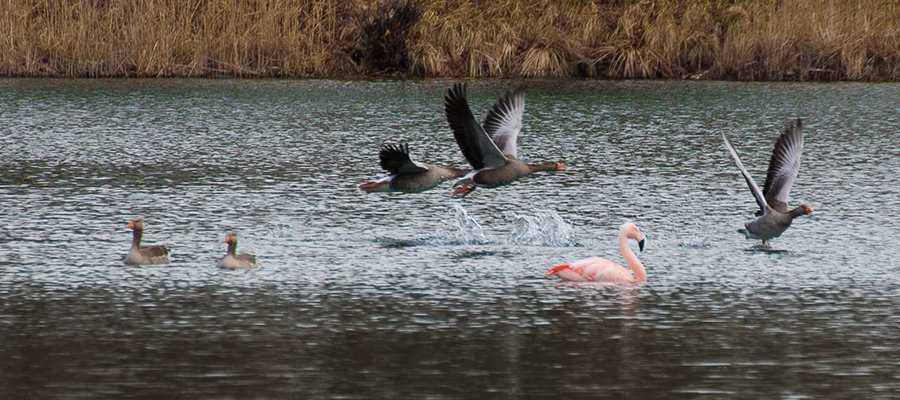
507 209 575 247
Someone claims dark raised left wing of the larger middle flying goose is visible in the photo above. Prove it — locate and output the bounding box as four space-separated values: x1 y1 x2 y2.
444 83 509 170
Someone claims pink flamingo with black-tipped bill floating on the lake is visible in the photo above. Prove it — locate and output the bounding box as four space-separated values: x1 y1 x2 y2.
544 222 647 282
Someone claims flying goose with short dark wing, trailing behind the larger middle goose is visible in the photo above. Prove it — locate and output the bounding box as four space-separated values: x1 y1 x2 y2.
359 144 469 193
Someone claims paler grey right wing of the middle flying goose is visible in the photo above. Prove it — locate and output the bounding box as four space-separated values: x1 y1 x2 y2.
482 86 525 158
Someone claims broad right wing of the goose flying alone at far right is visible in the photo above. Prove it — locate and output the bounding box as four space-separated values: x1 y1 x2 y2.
763 118 803 212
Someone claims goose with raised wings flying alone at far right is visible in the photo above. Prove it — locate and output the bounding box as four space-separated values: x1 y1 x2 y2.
722 118 812 246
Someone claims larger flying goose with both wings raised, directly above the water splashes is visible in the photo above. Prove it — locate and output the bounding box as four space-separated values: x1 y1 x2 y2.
444 83 566 197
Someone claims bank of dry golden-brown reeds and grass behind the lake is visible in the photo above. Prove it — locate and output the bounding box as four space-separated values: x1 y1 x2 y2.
0 0 900 81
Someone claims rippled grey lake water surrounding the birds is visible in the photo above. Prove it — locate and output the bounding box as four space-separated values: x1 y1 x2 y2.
0 80 900 399
